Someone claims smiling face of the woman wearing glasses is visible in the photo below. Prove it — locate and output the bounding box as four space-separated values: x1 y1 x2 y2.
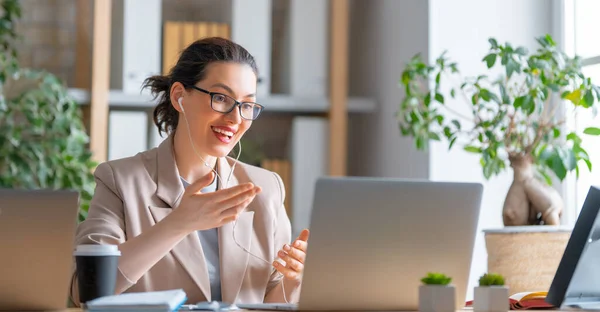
175 63 257 157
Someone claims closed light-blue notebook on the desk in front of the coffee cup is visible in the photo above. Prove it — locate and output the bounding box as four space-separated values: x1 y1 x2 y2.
86 289 187 312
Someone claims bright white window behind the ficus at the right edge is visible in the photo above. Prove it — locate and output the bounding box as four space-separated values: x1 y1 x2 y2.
561 0 600 224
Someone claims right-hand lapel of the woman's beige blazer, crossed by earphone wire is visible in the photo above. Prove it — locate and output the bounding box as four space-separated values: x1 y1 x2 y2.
218 158 254 303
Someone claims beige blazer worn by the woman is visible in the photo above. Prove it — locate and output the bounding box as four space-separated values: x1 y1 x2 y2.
71 136 291 303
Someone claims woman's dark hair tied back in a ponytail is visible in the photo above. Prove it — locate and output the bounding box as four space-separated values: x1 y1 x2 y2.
143 37 258 135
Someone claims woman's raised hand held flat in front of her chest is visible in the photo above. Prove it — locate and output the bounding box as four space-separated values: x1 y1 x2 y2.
170 172 261 234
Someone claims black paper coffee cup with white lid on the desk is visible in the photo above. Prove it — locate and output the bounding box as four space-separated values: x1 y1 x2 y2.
73 245 121 305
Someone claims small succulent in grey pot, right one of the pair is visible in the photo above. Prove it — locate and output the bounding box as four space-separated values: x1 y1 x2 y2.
473 273 510 312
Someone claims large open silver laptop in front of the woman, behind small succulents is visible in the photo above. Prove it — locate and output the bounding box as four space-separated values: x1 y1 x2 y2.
238 177 483 311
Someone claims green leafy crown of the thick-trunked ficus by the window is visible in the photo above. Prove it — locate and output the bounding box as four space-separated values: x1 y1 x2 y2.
398 35 600 184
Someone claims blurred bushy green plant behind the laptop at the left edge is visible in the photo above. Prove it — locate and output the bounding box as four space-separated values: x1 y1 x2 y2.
0 0 96 221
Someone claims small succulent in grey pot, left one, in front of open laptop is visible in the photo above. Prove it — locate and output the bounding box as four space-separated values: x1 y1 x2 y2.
419 273 456 312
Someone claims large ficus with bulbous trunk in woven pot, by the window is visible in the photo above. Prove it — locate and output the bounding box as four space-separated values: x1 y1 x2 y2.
397 35 600 292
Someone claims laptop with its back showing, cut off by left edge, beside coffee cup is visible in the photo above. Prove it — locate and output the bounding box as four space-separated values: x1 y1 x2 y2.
0 189 79 311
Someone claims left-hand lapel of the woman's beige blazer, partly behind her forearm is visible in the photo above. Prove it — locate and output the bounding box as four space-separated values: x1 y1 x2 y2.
148 135 212 301
